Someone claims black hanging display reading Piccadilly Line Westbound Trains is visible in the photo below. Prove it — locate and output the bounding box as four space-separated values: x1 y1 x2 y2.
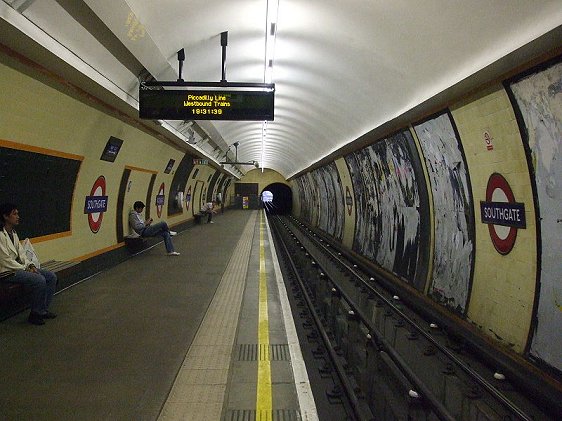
139 87 274 121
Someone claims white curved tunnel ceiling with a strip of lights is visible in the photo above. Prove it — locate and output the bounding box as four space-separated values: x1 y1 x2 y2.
4 0 562 177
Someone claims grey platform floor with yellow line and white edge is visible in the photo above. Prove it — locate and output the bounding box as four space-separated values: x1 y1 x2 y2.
0 211 317 421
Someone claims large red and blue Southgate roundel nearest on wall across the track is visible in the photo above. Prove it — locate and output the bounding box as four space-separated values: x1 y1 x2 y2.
480 173 527 254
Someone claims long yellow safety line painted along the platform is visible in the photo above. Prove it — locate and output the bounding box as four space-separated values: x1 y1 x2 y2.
256 213 273 421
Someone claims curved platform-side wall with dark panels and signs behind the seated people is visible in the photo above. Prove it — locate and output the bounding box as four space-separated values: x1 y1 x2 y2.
0 51 233 261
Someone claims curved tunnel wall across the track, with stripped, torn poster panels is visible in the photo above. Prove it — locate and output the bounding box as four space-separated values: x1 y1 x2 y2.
292 57 562 373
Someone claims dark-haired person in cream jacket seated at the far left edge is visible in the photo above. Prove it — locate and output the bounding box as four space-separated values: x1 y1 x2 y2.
0 203 57 325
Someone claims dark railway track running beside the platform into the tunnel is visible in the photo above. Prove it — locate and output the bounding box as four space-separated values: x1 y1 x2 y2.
269 217 555 420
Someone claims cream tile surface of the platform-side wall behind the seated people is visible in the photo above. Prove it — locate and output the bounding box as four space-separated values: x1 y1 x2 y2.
0 58 226 261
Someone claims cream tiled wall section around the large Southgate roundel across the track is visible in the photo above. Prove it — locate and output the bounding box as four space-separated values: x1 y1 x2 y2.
452 85 537 352
